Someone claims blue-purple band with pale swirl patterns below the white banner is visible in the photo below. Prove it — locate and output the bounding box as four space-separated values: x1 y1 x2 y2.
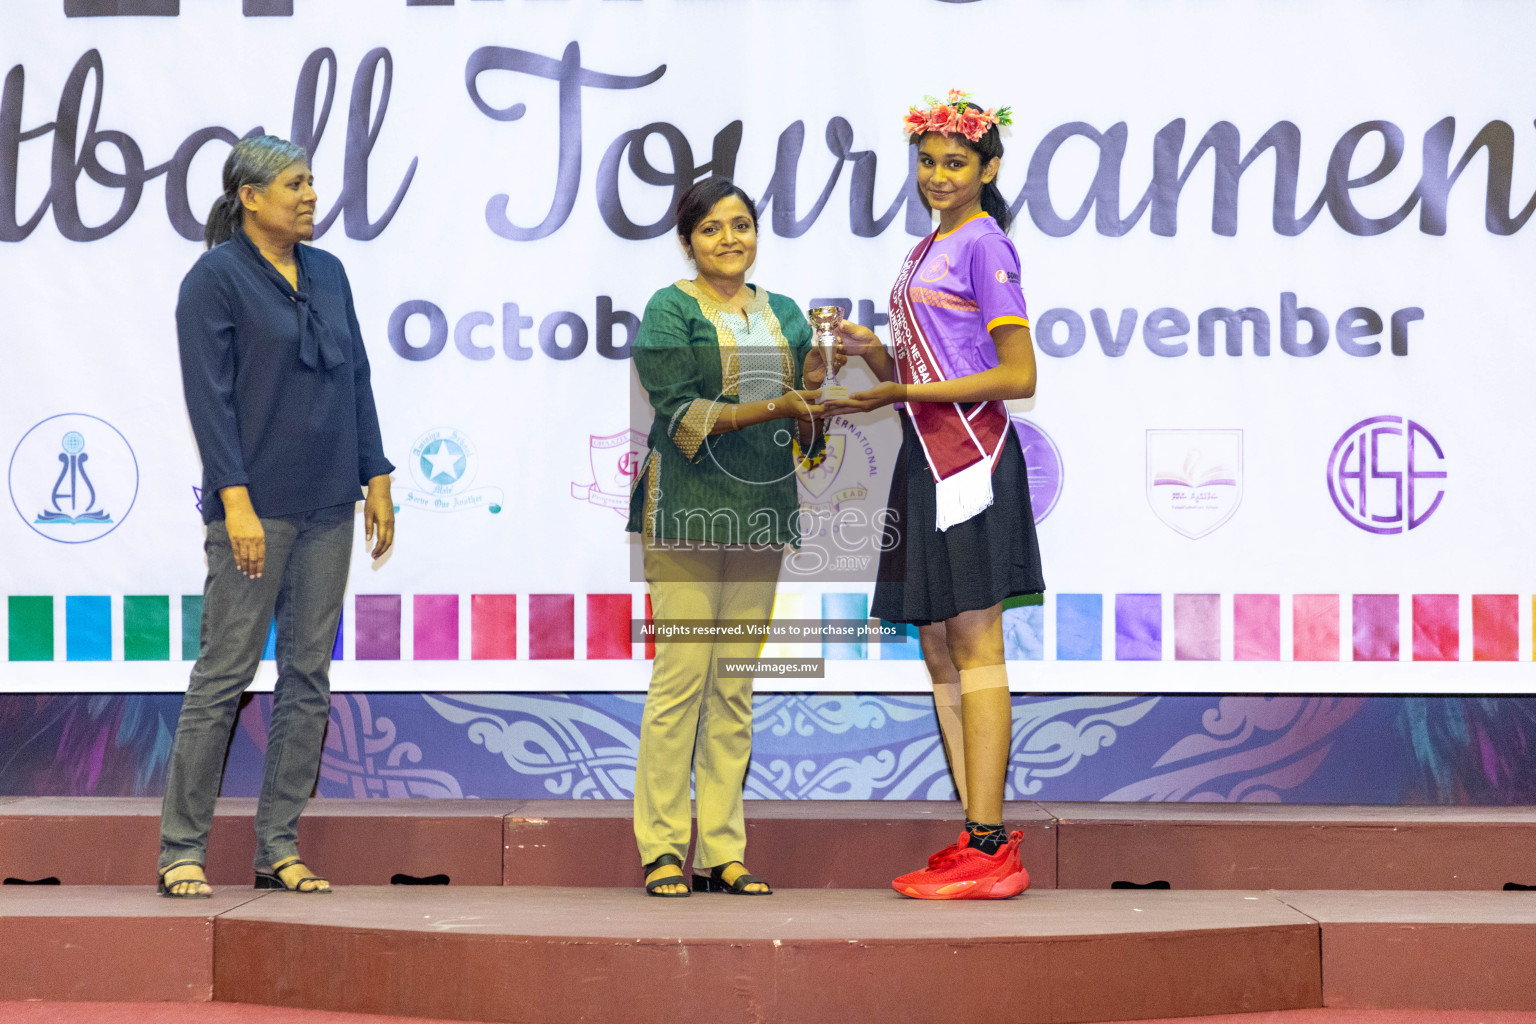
0 692 1536 806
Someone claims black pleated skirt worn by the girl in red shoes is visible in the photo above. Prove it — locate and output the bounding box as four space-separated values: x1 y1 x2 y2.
869 413 1046 625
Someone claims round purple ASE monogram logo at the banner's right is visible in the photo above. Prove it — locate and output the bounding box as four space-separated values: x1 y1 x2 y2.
1329 416 1447 533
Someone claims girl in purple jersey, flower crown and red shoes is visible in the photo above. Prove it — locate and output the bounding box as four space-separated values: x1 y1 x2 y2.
826 92 1044 900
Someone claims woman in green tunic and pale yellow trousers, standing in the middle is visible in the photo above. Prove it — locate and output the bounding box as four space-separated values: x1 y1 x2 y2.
628 178 825 897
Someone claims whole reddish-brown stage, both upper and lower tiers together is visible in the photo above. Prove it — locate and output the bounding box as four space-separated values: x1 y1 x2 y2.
0 798 1536 1024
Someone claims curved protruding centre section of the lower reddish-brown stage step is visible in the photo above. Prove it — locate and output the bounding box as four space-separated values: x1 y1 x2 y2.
215 887 1321 1024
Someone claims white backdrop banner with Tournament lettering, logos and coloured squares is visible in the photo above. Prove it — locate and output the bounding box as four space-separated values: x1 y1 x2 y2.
0 0 1536 692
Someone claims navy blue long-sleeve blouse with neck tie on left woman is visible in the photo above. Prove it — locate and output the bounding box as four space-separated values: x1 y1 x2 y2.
177 230 395 522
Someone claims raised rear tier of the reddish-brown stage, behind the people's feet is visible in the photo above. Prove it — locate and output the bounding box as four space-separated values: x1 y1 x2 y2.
0 797 1536 890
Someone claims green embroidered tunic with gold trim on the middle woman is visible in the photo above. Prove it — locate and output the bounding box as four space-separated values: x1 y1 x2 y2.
628 281 822 547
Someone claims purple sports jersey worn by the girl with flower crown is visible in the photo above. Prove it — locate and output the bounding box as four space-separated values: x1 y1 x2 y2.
906 213 1029 379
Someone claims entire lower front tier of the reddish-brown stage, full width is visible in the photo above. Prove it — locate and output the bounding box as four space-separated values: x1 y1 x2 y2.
0 886 1536 1024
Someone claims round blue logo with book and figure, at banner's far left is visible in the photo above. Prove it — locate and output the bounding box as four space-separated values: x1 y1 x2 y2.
9 413 138 543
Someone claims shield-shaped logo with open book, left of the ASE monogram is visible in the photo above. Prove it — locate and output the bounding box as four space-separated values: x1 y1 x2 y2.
1146 430 1243 540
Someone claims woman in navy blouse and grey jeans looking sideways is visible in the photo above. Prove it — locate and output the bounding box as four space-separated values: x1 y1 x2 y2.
160 135 395 897
